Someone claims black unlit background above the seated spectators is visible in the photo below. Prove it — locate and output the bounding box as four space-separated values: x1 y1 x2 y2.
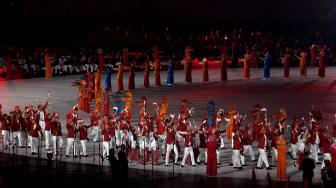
0 0 336 43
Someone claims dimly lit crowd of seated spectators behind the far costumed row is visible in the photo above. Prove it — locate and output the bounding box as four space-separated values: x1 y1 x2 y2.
0 27 336 79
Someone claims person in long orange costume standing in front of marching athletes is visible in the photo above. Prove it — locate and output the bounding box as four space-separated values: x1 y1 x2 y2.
276 137 287 180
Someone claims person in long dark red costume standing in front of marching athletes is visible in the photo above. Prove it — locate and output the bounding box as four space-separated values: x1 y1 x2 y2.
206 128 218 177
